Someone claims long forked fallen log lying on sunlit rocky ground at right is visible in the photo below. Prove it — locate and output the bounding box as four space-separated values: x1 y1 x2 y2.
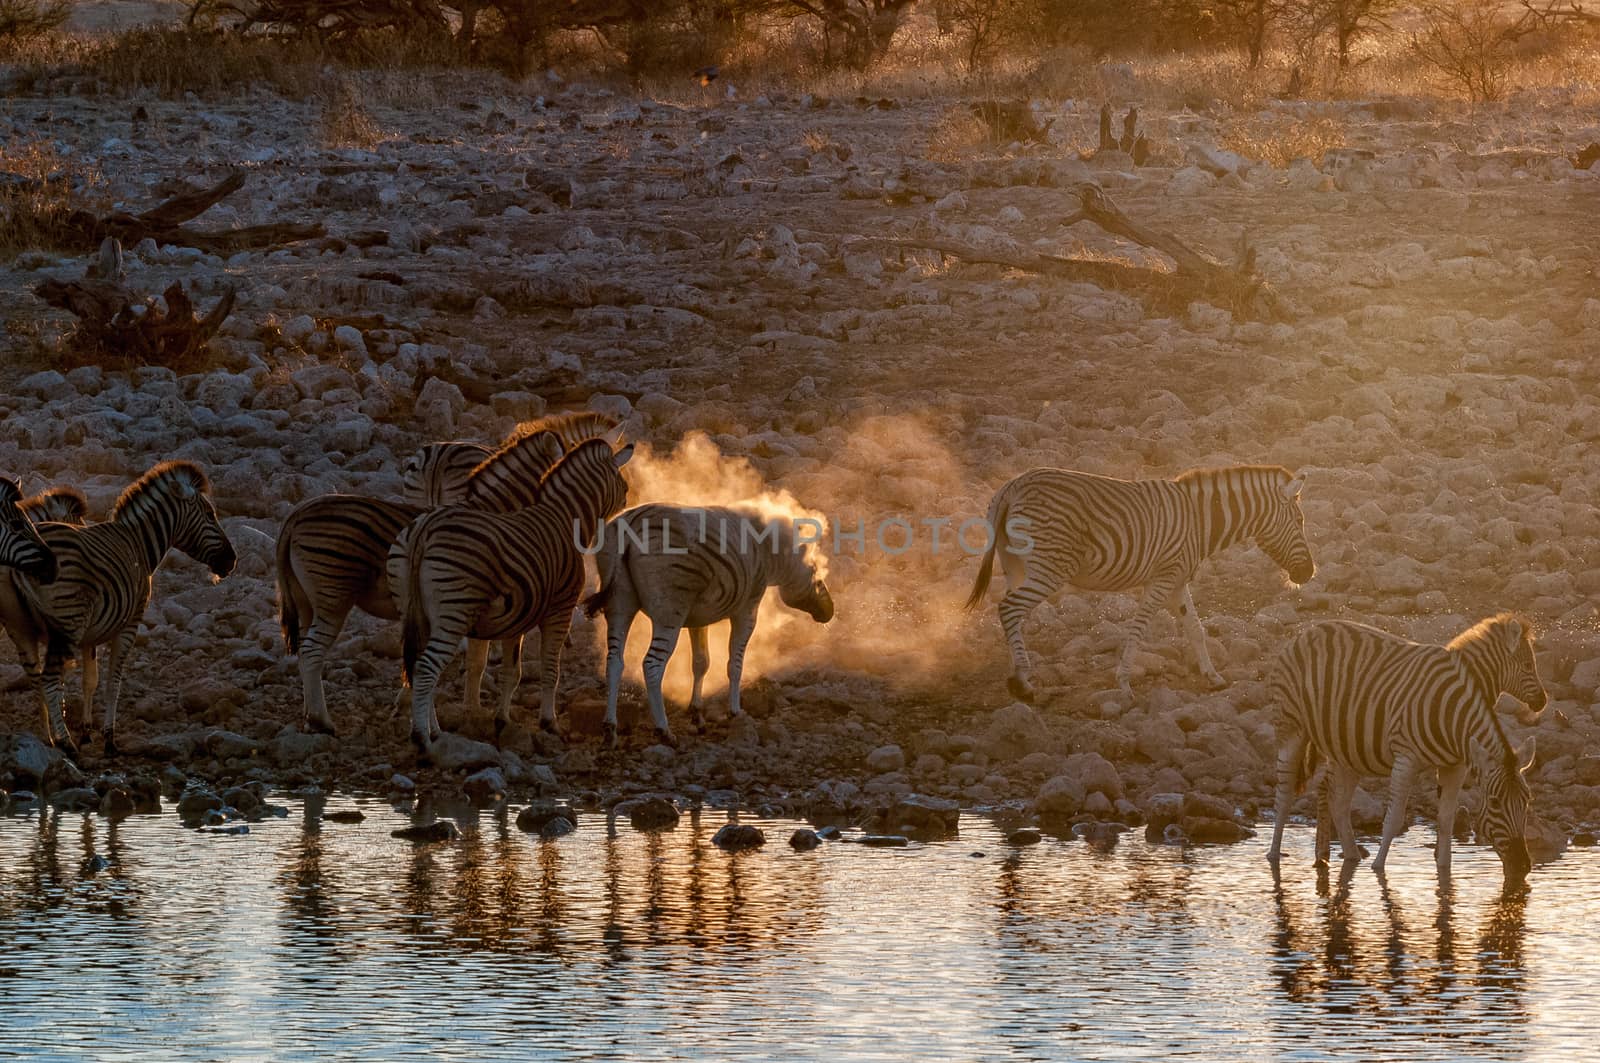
867 181 1283 319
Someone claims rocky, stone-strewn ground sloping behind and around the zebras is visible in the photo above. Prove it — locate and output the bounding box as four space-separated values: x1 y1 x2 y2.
0 56 1600 842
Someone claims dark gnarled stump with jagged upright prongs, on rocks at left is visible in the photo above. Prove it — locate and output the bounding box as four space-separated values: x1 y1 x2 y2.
34 237 235 370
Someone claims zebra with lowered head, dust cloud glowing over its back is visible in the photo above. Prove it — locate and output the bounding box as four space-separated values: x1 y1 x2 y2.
584 504 834 746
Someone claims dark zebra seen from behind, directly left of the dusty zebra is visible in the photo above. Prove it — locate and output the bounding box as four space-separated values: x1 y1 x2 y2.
403 439 634 759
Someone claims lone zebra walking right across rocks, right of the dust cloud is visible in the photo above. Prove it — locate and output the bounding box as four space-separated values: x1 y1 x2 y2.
966 466 1315 701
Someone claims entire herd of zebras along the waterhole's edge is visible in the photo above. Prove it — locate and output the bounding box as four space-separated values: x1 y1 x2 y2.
0 413 1546 879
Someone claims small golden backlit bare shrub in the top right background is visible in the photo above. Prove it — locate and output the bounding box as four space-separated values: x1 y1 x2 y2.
1411 0 1548 102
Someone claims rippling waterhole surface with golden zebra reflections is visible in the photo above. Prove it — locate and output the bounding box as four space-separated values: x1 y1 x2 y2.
0 797 1600 1060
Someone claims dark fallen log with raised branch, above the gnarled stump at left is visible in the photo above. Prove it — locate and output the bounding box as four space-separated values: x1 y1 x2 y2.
18 173 328 251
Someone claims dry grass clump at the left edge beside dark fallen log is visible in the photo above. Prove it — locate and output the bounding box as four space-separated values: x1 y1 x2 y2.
0 138 109 256
